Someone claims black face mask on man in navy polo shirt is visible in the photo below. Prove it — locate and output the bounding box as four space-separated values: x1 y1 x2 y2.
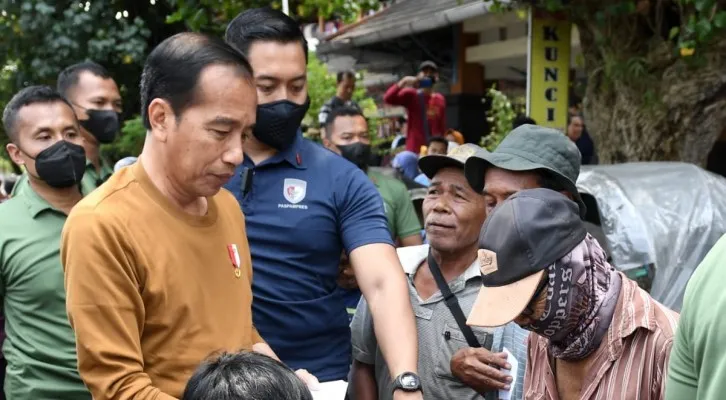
253 97 310 151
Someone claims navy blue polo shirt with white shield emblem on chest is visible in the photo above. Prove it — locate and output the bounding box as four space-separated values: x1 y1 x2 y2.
225 132 393 381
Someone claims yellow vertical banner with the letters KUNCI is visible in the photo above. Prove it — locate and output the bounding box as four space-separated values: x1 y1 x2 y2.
527 10 572 131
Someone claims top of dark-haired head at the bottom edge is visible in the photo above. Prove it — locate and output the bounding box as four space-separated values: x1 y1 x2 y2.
182 352 313 400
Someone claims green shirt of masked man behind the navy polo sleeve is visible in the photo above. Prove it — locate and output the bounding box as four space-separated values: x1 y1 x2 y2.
368 171 421 239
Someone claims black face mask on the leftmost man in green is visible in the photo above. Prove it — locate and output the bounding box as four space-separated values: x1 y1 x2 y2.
26 140 86 189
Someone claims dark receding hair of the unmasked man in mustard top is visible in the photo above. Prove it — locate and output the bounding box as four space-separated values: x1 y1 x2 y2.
140 32 252 129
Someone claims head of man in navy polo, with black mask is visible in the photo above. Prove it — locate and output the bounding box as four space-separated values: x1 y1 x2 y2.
224 7 310 151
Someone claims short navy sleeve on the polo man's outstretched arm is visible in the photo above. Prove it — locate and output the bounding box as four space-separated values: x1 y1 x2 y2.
335 167 393 254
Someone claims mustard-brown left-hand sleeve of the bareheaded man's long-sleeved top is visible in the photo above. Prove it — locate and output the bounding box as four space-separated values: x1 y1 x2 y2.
61 209 174 400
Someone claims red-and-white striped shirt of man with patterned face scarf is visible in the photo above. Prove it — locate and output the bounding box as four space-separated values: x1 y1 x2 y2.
524 273 678 400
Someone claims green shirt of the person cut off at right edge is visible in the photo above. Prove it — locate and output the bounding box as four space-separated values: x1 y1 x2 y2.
666 235 726 400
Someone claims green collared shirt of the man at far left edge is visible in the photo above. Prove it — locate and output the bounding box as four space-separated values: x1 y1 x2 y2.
0 182 91 400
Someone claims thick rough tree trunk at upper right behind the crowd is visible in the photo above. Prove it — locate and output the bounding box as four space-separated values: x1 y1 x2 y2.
574 15 726 166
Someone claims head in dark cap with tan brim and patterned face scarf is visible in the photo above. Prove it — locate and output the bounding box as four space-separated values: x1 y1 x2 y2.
467 189 621 360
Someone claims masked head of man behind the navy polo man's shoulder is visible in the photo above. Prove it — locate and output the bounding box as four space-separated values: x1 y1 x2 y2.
323 106 371 171
